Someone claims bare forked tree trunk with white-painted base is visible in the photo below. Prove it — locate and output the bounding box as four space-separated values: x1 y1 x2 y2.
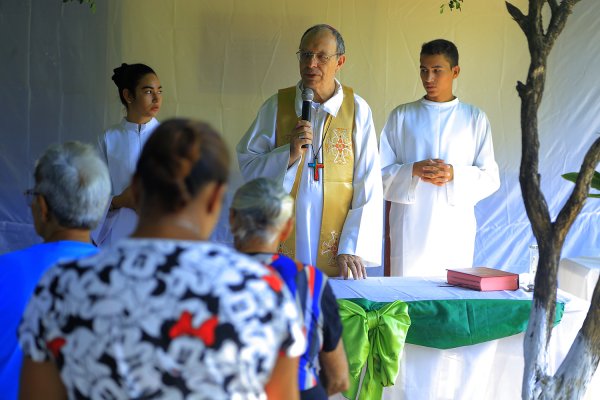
506 0 600 399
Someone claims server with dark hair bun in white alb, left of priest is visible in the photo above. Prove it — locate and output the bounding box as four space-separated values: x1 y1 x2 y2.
92 64 162 247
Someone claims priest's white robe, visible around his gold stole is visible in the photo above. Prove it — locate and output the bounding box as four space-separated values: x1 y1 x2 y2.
236 80 383 267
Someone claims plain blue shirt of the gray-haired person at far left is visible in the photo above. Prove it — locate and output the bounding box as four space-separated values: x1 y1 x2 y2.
0 241 98 400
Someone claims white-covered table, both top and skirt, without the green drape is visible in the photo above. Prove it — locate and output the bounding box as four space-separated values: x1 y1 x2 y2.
330 277 600 400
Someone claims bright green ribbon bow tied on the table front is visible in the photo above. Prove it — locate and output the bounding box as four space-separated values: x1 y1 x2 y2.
338 299 410 400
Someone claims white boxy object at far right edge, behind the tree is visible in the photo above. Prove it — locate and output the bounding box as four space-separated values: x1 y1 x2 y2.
558 257 600 301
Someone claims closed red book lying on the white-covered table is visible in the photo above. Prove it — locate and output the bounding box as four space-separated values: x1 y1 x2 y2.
448 267 519 292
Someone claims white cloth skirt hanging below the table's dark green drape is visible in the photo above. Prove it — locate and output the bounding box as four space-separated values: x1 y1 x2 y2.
383 290 600 400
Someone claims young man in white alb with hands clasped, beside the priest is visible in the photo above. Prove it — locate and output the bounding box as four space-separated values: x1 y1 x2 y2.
380 39 500 276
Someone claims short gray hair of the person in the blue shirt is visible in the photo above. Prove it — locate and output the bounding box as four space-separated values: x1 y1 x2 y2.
35 141 110 229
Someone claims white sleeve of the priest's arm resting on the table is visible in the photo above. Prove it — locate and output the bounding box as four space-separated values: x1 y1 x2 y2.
338 95 383 267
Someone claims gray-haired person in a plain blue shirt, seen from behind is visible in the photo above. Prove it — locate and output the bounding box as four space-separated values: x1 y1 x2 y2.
0 142 110 400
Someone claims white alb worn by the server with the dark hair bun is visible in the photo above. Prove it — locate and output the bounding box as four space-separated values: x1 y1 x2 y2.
92 118 159 247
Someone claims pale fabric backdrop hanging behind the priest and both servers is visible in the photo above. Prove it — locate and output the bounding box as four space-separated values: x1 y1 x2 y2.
0 0 600 272
